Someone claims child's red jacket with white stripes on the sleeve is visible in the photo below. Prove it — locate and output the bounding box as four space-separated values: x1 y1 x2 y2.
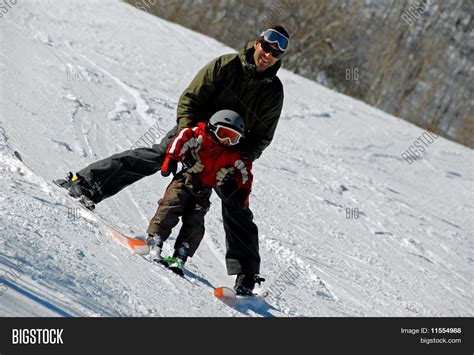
163 122 253 190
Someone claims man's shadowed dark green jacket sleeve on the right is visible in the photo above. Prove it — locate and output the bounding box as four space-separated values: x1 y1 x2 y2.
243 81 284 161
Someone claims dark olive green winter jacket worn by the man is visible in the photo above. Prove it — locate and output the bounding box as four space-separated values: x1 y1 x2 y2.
177 45 283 161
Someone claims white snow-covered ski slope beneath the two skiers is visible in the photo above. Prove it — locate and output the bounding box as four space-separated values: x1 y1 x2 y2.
0 1 474 317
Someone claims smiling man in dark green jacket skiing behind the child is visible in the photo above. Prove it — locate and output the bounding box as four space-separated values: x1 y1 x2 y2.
59 25 289 294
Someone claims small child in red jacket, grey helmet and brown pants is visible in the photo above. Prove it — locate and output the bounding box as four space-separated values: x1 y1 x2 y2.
147 110 252 275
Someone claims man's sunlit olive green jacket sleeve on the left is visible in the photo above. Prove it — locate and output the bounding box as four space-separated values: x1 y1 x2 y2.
177 57 221 129
